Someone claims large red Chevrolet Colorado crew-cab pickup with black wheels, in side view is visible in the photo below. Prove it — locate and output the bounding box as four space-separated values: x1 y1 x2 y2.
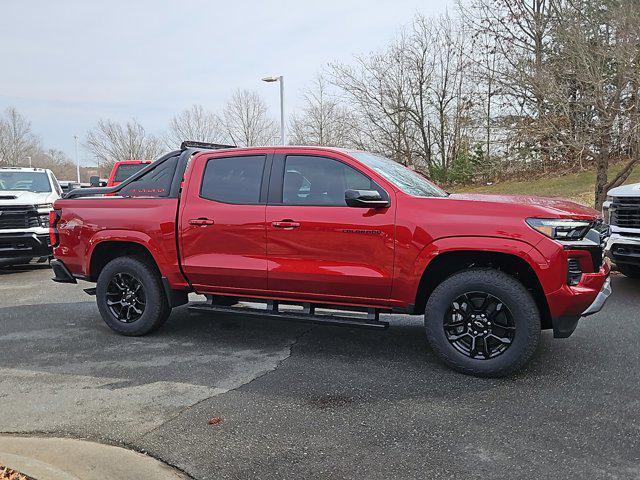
50 144 611 376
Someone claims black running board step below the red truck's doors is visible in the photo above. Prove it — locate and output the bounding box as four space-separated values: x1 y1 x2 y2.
189 302 389 330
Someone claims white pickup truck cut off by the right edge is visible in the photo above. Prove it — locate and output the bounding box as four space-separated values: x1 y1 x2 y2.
603 183 640 278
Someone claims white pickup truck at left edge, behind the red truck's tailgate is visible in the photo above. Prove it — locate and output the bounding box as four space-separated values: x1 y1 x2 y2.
0 167 62 266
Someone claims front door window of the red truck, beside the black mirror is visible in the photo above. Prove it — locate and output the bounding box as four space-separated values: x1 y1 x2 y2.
282 155 377 206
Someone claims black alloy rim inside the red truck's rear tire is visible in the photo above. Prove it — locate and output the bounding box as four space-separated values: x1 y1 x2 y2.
107 272 146 323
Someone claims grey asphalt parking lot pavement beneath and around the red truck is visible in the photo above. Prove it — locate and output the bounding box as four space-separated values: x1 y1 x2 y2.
0 266 640 479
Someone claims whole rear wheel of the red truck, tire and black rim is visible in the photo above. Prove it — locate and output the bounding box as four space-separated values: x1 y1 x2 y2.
96 257 171 336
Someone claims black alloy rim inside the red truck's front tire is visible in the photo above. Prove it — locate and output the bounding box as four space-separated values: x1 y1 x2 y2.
443 292 516 360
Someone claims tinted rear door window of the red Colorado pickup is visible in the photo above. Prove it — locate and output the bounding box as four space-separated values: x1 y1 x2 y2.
200 155 266 205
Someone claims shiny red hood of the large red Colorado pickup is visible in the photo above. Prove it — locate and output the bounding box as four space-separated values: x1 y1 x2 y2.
449 193 600 220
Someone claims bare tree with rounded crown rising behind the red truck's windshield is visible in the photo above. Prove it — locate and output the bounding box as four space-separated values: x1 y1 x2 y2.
331 15 475 180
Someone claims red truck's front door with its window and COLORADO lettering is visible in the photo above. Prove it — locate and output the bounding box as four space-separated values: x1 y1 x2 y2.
266 155 395 303
